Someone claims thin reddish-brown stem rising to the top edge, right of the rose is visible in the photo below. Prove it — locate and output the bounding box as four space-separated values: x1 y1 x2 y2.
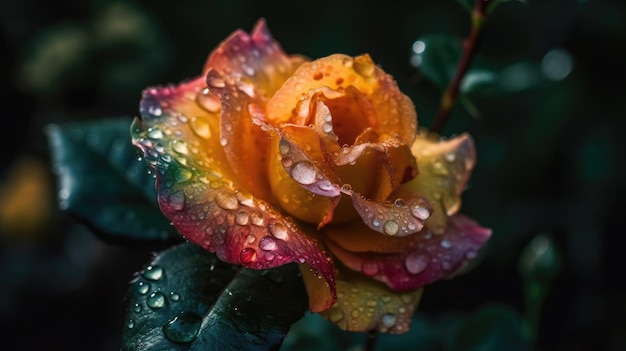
432 0 491 133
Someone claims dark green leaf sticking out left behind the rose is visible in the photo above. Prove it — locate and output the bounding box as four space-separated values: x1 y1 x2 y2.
46 118 180 241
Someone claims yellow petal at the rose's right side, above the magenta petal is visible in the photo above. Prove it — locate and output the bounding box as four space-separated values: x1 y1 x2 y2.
392 130 476 234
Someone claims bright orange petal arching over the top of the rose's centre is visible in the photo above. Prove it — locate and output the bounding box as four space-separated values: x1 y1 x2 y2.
267 54 417 145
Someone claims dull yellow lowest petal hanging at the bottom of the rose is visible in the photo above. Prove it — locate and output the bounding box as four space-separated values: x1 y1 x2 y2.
314 267 422 334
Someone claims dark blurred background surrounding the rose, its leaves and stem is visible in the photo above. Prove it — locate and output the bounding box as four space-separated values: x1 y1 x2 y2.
0 0 626 351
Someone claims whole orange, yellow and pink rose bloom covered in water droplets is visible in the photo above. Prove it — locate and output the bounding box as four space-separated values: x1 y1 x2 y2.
131 20 490 333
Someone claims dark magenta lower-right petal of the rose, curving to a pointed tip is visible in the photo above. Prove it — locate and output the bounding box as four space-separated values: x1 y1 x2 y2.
326 214 491 291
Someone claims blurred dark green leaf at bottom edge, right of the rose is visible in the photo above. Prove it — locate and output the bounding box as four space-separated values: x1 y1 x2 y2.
444 304 531 351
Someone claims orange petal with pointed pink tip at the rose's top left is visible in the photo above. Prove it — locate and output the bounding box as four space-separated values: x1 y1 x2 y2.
203 20 304 200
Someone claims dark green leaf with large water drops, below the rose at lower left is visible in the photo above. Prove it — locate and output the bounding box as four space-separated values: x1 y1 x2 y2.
122 243 308 351
